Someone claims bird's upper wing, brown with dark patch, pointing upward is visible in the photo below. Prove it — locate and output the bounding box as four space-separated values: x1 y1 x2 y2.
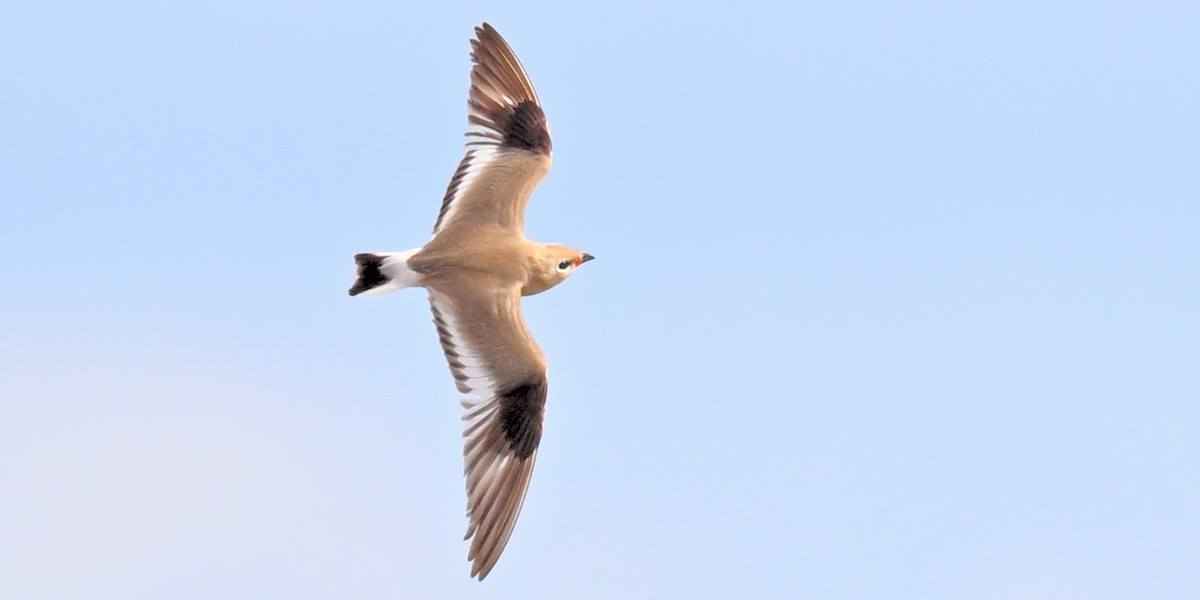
433 23 551 239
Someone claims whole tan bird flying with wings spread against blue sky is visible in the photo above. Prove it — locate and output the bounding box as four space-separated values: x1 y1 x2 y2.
349 23 594 581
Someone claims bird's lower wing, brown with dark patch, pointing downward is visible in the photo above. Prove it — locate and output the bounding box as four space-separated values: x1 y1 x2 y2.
428 274 546 580
